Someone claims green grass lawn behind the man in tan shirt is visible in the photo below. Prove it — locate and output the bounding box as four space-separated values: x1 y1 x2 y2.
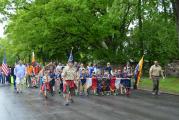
139 77 179 94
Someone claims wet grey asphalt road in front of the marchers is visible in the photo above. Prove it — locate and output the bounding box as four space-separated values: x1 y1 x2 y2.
0 86 179 120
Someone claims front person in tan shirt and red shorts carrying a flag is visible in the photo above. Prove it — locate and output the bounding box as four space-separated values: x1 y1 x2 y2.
62 48 76 106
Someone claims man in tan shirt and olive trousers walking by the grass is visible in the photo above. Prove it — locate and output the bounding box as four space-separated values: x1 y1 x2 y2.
149 61 164 95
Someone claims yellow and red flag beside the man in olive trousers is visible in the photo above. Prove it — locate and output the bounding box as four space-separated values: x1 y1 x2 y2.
134 56 144 87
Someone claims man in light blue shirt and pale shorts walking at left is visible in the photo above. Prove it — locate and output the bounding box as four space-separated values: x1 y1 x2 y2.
14 61 26 93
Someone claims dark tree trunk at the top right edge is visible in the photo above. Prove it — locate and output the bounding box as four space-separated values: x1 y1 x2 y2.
175 0 179 47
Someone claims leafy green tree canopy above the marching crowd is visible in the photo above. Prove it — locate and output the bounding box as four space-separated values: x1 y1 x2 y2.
0 0 179 64
